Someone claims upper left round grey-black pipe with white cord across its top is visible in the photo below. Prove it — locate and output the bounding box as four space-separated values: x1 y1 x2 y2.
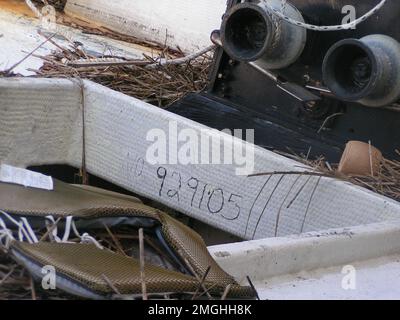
221 0 307 69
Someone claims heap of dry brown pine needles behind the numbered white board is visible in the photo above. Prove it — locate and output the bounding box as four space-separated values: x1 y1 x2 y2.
31 40 213 107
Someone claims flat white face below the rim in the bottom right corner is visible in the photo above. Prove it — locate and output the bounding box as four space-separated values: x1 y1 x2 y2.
255 255 400 300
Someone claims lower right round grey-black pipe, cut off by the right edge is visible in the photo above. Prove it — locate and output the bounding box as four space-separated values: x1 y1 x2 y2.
322 34 400 107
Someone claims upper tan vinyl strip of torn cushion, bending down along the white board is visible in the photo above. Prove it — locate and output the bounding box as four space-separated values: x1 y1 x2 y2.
0 180 256 296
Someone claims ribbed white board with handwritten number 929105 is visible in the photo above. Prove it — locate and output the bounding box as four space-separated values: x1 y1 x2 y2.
0 79 400 239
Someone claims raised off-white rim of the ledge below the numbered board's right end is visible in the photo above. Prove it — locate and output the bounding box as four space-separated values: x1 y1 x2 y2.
208 221 400 282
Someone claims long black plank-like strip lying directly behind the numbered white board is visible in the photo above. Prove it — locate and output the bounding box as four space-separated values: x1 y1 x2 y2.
168 94 342 162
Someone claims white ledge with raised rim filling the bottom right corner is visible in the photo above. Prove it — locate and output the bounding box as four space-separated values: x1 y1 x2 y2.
208 221 400 300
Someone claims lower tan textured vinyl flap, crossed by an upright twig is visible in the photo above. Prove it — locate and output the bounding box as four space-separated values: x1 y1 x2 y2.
11 241 251 296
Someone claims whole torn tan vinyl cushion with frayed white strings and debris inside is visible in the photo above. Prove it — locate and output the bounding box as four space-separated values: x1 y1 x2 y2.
0 170 254 300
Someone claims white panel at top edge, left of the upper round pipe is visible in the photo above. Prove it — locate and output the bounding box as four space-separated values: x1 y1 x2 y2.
65 0 226 52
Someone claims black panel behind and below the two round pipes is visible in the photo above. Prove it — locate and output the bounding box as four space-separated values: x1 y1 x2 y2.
169 0 400 161
